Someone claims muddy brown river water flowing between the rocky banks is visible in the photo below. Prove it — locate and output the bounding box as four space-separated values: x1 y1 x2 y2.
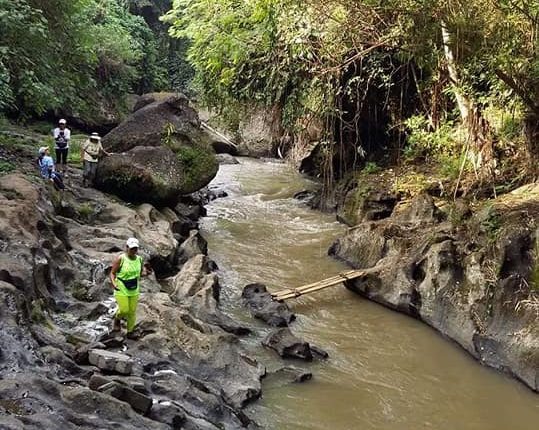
202 159 539 430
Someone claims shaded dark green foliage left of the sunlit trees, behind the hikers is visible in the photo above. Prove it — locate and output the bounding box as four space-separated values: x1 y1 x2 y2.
0 0 166 117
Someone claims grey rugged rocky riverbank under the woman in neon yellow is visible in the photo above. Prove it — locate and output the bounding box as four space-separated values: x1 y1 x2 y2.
0 136 265 429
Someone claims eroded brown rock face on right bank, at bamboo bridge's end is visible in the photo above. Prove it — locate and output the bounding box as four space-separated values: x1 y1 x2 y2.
330 184 539 391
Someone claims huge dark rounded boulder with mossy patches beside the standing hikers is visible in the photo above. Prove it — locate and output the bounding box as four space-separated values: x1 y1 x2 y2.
99 93 219 205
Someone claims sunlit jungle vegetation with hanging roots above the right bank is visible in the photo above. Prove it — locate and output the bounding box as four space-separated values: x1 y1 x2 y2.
165 0 539 190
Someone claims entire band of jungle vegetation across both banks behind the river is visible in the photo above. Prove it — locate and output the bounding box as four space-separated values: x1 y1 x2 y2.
0 0 539 191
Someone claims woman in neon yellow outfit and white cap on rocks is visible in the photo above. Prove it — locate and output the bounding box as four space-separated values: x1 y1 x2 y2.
110 237 151 335
